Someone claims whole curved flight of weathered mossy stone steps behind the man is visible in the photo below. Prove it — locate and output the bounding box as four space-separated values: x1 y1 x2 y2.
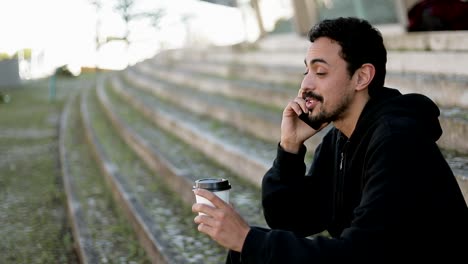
60 32 468 263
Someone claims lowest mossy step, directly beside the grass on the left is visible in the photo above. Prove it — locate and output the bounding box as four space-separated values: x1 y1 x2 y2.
59 88 149 263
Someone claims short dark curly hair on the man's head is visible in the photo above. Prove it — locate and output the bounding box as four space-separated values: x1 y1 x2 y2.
308 17 387 97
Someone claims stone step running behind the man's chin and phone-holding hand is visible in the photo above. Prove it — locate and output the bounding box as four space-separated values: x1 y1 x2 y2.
123 64 328 159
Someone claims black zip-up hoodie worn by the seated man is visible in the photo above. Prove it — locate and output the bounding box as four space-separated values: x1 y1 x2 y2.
236 88 468 264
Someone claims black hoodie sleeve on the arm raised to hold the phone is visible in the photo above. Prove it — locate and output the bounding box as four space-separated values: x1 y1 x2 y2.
262 129 335 237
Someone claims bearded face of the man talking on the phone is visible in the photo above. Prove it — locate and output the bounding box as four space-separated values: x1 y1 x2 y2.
299 37 354 127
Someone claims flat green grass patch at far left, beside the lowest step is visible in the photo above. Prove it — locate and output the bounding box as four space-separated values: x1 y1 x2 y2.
0 75 81 263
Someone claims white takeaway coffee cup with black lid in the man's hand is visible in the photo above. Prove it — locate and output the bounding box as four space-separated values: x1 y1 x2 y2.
193 178 231 213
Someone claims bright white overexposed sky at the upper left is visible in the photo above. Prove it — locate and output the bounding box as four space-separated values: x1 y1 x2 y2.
0 0 292 74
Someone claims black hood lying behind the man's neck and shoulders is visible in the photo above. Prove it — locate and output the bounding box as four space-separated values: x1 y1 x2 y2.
351 88 442 142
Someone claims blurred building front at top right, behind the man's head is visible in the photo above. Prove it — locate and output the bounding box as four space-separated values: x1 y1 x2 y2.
291 0 468 35
